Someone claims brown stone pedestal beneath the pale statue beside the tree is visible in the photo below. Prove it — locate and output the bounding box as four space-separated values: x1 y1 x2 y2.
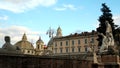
92 55 120 68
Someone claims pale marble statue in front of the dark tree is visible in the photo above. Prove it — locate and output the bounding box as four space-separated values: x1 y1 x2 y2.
100 21 114 53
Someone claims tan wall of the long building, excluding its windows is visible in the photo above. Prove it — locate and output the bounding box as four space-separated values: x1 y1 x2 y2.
53 35 98 54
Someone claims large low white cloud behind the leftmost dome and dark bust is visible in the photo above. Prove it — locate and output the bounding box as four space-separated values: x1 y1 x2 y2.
0 26 45 46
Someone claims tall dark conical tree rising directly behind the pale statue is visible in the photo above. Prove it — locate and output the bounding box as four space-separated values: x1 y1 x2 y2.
97 3 115 46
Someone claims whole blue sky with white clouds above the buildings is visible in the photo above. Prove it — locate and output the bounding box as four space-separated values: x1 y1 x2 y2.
0 0 120 47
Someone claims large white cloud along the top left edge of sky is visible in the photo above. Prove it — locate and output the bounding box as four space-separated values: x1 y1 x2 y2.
0 0 57 13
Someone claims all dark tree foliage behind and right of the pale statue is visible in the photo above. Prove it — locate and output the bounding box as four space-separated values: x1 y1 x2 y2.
97 3 120 46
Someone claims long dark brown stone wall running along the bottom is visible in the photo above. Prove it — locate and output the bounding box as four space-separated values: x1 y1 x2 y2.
0 54 92 68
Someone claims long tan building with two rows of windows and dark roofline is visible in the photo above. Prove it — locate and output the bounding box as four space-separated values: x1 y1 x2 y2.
51 27 98 55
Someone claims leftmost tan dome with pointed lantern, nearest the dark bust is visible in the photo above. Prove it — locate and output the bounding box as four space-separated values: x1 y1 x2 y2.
15 34 34 49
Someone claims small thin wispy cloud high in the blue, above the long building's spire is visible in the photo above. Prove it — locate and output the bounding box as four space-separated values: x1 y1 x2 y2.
54 4 77 11
